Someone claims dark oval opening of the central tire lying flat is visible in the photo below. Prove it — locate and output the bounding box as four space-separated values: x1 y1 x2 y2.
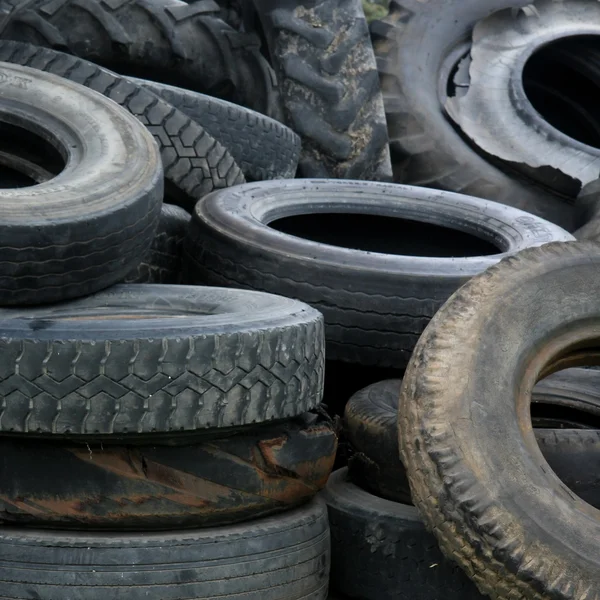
269 213 502 258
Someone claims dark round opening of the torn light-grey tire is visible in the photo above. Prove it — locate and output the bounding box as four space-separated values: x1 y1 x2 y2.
523 36 600 148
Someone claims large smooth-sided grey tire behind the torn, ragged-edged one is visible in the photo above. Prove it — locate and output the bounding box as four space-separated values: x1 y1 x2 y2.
371 0 577 231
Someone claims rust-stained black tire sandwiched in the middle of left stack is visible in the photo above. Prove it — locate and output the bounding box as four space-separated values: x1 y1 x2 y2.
0 413 337 530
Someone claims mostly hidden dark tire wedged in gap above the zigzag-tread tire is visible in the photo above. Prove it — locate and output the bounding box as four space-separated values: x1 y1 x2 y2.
123 204 192 285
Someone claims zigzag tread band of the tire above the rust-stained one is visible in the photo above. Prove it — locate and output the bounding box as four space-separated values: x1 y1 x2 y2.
0 320 324 435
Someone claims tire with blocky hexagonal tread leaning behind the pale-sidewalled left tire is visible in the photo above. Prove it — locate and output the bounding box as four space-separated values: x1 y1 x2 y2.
0 41 245 212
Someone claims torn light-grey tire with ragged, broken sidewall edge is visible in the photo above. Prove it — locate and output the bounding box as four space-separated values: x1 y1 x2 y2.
446 0 600 195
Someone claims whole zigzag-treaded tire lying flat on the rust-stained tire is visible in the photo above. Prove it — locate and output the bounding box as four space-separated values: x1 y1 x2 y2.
0 285 323 439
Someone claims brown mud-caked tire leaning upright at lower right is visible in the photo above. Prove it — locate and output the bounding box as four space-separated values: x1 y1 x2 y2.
399 242 600 600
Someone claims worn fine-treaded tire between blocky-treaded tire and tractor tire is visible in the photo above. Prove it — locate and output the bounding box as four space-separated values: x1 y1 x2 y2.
130 78 300 181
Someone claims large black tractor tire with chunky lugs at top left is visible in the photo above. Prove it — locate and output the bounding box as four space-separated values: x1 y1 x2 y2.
0 0 281 118
